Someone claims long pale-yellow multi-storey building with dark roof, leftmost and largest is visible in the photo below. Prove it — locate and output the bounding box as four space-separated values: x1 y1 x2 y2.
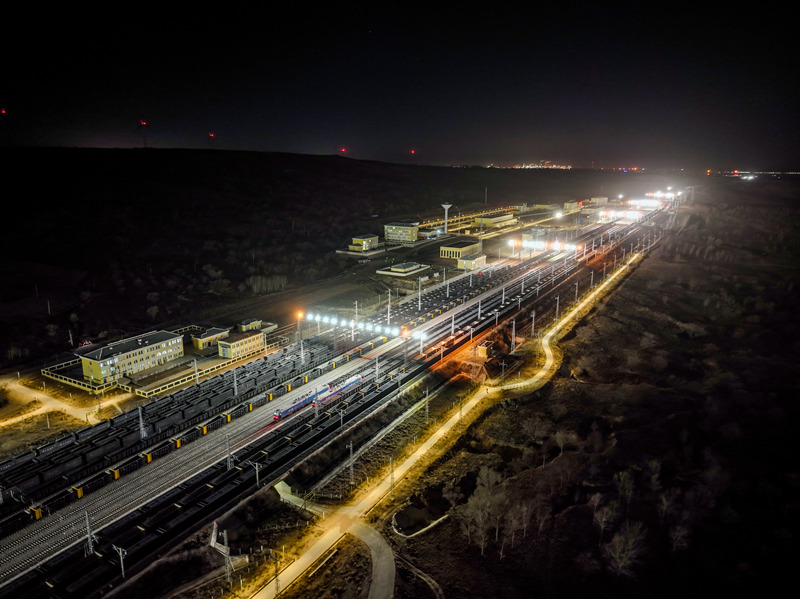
78 331 183 384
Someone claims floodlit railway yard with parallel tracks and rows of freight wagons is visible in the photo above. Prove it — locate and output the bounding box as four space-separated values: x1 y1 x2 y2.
0 204 670 598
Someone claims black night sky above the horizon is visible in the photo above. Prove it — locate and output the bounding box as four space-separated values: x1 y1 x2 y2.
0 2 800 170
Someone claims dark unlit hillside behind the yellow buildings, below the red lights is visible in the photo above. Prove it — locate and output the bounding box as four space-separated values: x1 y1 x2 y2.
0 148 680 363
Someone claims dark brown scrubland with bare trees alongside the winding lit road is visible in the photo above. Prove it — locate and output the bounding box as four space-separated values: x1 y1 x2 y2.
148 178 800 597
